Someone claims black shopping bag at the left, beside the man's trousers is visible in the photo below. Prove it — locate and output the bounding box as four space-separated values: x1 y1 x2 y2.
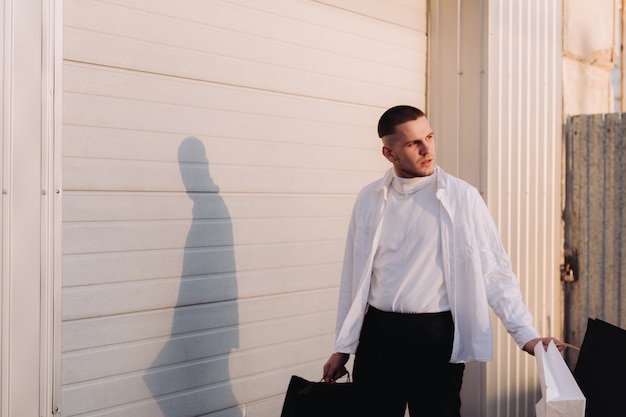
280 375 357 417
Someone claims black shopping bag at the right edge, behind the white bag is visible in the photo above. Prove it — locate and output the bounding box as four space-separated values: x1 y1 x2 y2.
574 318 626 417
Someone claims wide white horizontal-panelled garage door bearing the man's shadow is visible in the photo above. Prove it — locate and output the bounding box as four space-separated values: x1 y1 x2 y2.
62 0 426 417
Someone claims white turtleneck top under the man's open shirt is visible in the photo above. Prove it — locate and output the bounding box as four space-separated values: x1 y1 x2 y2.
368 171 450 313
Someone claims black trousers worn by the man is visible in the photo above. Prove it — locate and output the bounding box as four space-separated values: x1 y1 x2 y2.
352 307 465 417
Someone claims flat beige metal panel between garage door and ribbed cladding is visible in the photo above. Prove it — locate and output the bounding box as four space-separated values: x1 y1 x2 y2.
427 0 486 416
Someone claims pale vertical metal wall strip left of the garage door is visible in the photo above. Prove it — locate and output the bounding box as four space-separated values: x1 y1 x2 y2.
0 0 61 417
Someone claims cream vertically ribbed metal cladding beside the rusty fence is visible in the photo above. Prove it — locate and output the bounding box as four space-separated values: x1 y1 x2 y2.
484 0 562 417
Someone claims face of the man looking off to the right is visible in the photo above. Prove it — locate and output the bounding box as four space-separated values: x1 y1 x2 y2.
383 117 435 178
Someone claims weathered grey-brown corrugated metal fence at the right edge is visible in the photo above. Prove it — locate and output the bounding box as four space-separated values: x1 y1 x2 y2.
564 113 626 369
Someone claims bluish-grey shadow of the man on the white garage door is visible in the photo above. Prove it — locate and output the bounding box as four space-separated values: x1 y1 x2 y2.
144 137 242 417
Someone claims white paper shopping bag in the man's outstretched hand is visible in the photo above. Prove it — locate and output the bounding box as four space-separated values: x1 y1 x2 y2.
535 341 587 417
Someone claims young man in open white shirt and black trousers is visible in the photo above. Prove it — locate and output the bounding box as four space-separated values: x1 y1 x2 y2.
324 106 551 417
